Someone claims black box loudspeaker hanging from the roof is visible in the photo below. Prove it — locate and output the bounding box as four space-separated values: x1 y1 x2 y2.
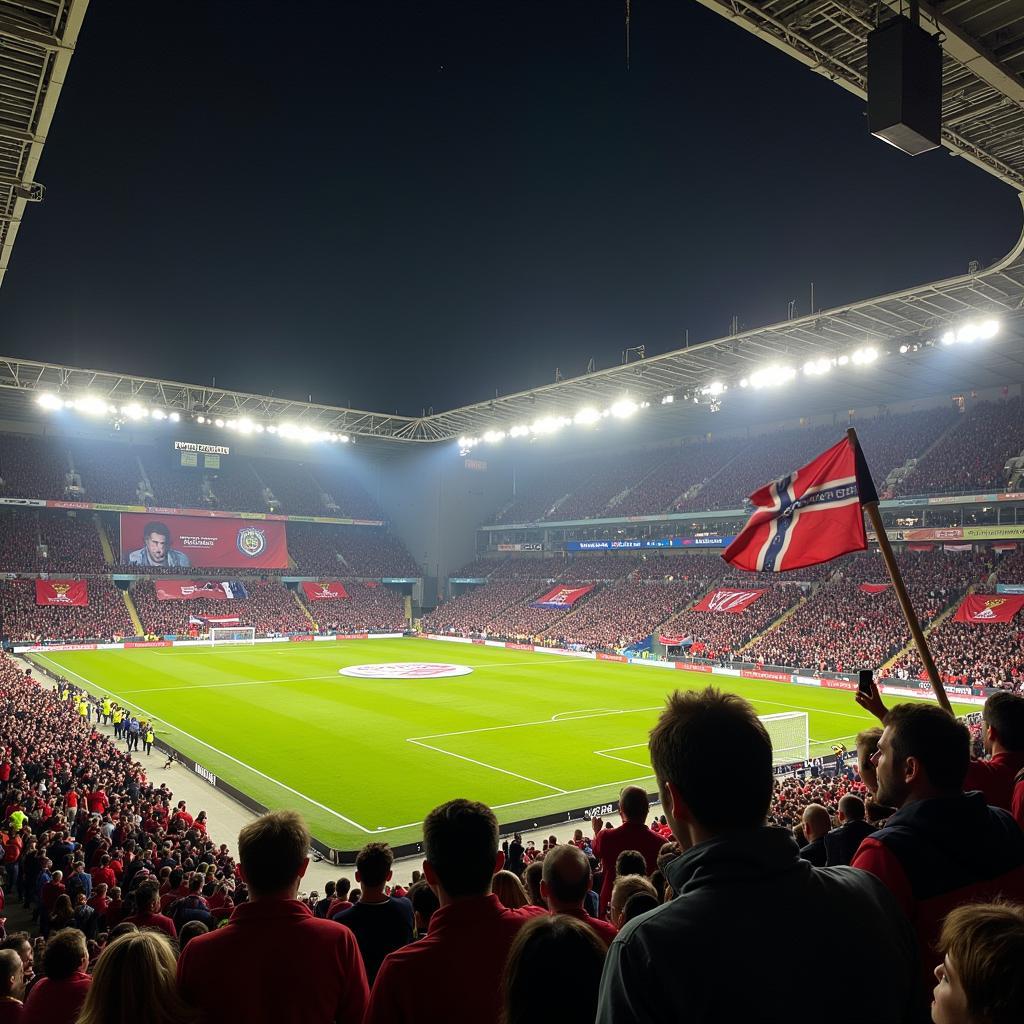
867 14 942 157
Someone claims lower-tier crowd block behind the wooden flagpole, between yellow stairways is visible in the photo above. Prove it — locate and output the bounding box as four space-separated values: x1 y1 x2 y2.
748 552 984 673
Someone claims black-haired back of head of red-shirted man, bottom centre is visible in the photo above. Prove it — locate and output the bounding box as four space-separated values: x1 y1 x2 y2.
423 800 505 905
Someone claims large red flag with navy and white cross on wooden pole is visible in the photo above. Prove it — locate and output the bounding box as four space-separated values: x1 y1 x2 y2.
722 437 879 572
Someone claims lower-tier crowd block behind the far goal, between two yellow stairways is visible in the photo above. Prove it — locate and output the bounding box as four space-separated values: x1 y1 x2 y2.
132 579 310 636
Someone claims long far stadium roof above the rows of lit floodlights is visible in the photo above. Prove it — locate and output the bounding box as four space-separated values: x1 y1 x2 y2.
0 195 1024 442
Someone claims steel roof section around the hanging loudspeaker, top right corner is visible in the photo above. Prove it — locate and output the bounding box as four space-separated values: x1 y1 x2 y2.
699 0 1024 190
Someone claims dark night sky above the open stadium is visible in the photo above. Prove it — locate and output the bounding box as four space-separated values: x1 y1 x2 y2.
0 0 1019 414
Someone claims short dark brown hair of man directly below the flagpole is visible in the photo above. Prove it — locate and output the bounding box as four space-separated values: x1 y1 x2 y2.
885 703 971 793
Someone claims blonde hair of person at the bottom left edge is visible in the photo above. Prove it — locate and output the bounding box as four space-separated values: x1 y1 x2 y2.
78 931 197 1024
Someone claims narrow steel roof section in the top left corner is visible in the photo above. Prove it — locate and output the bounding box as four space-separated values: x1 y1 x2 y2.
0 0 89 285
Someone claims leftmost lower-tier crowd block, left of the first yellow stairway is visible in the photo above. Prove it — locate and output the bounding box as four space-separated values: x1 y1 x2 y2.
0 577 135 643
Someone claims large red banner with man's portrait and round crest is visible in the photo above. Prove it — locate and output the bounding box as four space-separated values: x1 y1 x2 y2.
121 512 288 569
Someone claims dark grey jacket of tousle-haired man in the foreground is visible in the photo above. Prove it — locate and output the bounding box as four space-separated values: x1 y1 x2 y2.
597 827 920 1024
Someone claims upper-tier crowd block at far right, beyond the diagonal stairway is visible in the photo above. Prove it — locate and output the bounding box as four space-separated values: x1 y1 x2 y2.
899 396 1024 495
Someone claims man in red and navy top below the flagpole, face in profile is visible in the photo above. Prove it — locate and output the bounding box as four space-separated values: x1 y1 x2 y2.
853 703 1024 977
